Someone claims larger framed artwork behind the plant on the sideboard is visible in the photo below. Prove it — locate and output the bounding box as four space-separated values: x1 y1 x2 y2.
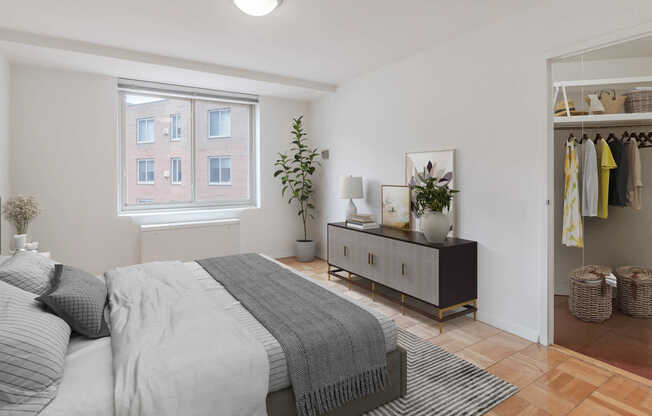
405 150 455 237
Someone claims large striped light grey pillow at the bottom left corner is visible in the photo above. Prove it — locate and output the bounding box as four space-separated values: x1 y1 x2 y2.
0 282 70 415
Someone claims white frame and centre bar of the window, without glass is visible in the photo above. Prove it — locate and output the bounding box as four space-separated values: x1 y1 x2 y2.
116 79 261 216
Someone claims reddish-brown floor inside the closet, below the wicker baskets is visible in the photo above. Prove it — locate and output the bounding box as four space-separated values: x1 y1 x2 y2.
555 296 652 380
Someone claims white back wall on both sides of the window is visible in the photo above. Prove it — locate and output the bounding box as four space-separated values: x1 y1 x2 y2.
10 65 307 273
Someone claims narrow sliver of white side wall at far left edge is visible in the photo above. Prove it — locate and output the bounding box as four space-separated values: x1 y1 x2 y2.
0 53 11 254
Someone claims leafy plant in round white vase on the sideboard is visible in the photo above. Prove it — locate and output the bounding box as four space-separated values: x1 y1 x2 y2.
414 177 459 243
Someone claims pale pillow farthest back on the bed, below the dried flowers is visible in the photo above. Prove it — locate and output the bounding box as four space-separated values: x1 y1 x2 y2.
0 251 55 295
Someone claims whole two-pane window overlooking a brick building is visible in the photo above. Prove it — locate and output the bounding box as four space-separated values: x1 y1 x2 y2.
118 79 259 215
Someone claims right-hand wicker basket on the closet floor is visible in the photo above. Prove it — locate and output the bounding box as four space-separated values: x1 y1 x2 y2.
616 266 652 318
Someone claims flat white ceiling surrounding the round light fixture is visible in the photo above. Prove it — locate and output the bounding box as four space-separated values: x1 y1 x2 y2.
0 0 532 98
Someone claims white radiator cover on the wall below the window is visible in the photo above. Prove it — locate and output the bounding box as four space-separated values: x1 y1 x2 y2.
140 220 240 263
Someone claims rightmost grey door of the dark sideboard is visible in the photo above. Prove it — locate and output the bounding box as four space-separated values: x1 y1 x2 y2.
387 241 439 305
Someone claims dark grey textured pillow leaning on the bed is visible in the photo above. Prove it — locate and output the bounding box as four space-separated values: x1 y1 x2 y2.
36 264 109 338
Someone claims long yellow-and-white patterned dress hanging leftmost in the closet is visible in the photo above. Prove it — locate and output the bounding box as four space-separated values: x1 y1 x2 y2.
561 140 584 247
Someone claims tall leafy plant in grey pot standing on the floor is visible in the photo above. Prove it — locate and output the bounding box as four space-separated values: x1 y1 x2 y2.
274 116 321 262
